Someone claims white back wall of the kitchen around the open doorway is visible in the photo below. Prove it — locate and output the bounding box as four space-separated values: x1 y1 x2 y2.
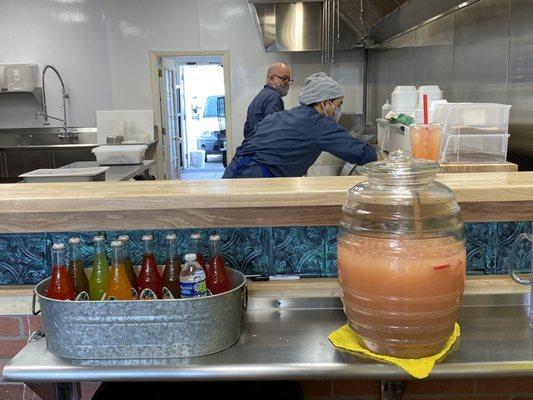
0 0 363 152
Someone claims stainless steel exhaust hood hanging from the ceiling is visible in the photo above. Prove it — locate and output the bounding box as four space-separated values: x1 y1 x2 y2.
248 0 479 51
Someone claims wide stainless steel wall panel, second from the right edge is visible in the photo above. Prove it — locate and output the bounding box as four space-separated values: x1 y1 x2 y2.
453 0 509 103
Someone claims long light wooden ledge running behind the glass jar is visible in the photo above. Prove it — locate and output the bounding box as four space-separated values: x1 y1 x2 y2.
0 172 533 232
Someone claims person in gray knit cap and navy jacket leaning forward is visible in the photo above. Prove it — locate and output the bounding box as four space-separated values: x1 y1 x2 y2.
223 72 377 178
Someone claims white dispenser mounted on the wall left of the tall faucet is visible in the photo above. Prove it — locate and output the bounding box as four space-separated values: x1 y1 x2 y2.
0 64 40 93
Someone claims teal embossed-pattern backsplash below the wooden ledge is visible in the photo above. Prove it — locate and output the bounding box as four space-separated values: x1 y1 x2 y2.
0 222 532 285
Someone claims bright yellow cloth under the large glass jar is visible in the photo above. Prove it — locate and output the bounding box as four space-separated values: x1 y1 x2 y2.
328 322 461 379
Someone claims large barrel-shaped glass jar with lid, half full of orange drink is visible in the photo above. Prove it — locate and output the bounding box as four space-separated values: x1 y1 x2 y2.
337 151 466 358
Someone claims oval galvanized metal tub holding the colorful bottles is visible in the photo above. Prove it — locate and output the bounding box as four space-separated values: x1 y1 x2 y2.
33 268 247 360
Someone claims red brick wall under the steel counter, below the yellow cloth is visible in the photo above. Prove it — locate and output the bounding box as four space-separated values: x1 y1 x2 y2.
301 378 533 400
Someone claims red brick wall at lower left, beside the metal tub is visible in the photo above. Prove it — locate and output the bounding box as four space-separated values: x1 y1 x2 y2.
0 315 98 400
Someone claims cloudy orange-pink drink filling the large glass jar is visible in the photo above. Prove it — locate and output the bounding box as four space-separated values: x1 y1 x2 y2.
337 234 466 358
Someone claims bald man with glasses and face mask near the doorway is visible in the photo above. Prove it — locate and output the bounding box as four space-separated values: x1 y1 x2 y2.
244 63 292 139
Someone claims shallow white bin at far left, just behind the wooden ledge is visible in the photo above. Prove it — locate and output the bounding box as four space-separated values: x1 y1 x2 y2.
19 167 109 183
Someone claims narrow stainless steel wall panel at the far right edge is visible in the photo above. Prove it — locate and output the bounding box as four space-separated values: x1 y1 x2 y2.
508 0 533 157
